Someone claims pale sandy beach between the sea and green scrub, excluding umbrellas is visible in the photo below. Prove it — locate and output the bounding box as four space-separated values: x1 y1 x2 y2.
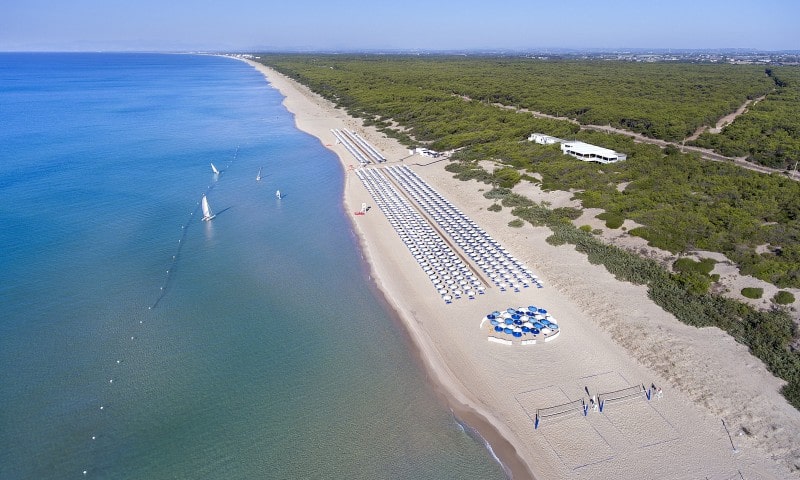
234 58 800 480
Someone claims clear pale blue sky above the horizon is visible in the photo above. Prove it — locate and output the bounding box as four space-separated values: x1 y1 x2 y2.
0 0 800 52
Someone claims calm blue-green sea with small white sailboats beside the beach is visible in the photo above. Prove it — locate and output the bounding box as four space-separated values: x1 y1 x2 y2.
0 53 506 480
